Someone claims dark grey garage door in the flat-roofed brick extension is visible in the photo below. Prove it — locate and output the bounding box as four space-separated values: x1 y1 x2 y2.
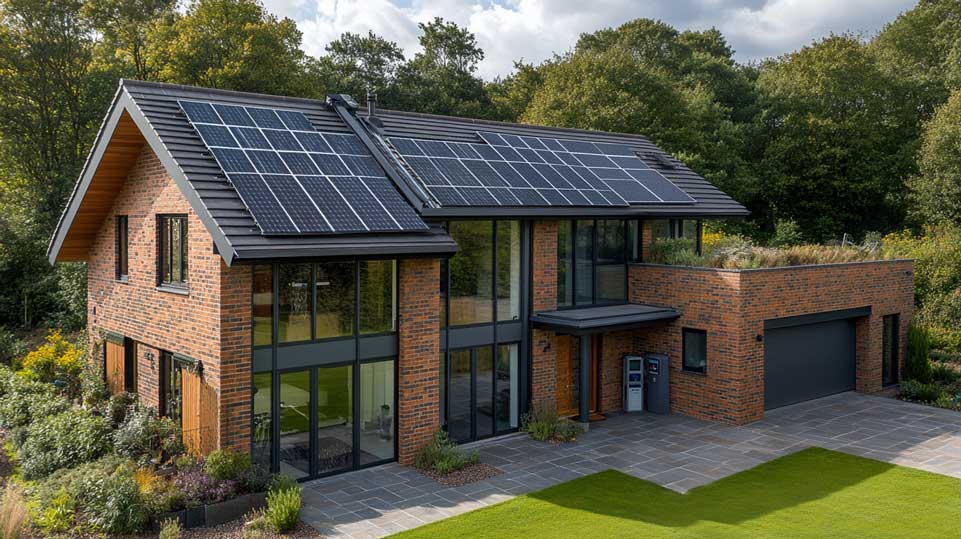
764 319 855 410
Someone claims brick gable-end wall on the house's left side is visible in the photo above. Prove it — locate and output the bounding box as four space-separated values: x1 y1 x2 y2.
87 146 250 450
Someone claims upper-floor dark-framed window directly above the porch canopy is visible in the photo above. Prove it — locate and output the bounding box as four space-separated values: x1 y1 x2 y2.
557 219 637 308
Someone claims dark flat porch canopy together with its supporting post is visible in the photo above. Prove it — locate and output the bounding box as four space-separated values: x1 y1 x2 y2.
531 303 681 428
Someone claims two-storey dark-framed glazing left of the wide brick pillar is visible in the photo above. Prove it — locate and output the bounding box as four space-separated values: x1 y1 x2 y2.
251 260 397 478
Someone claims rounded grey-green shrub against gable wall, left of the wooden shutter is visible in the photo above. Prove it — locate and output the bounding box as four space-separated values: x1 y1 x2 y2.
113 401 184 464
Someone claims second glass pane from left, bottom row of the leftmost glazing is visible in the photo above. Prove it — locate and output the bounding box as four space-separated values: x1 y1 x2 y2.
279 370 310 478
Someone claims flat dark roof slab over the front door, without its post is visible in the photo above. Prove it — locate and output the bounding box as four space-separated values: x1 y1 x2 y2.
531 304 681 335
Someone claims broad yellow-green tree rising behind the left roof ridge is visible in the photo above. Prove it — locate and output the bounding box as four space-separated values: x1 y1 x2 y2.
147 0 317 96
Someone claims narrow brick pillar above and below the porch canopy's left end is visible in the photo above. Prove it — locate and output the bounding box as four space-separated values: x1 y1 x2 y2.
531 221 557 406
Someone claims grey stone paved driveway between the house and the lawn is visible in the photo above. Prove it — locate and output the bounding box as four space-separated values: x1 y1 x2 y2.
302 393 961 538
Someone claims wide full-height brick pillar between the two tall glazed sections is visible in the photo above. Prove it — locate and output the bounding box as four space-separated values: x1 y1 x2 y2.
397 259 440 465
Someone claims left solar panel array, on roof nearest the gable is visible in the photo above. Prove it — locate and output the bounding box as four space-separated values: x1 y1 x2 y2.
180 101 428 234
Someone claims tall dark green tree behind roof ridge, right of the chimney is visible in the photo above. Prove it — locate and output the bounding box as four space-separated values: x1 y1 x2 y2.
397 17 495 118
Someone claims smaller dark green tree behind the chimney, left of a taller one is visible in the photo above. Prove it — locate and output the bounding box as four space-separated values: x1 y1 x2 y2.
321 32 404 101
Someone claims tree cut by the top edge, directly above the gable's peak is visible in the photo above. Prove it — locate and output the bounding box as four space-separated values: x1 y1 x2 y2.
82 0 177 80
